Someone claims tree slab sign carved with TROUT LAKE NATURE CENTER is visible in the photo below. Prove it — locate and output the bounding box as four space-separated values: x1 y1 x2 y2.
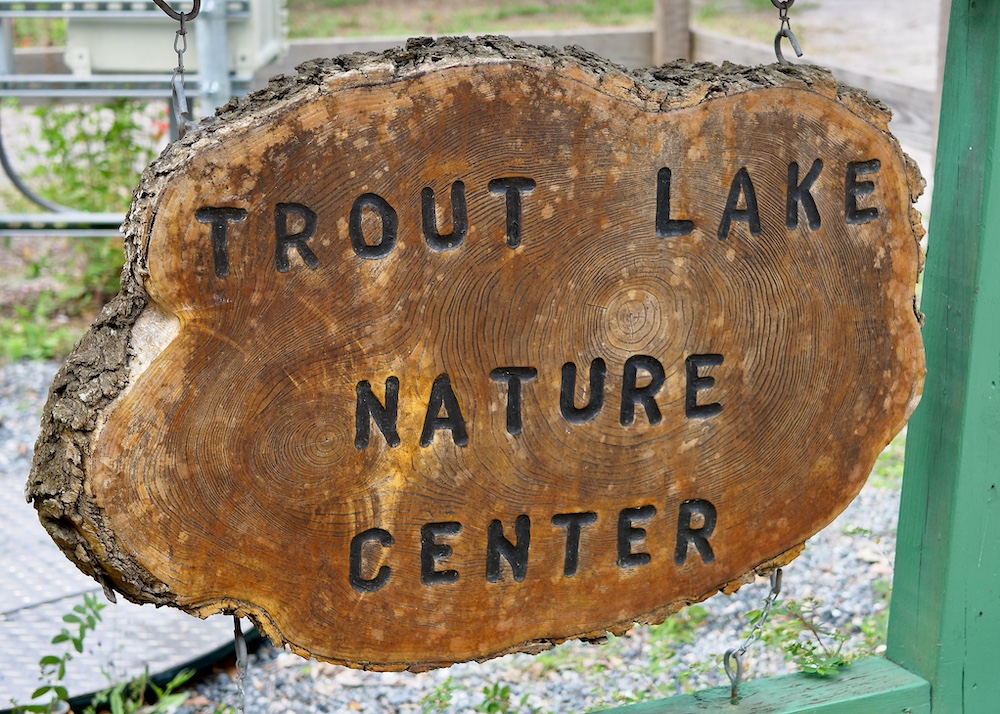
28 37 924 669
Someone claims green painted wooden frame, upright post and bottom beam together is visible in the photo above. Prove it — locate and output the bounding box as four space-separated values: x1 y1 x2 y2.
600 0 1000 714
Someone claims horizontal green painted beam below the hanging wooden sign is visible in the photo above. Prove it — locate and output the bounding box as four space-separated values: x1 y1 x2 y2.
592 657 928 714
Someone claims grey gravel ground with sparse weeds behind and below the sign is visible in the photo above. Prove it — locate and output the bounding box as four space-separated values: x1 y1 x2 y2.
0 362 899 714
